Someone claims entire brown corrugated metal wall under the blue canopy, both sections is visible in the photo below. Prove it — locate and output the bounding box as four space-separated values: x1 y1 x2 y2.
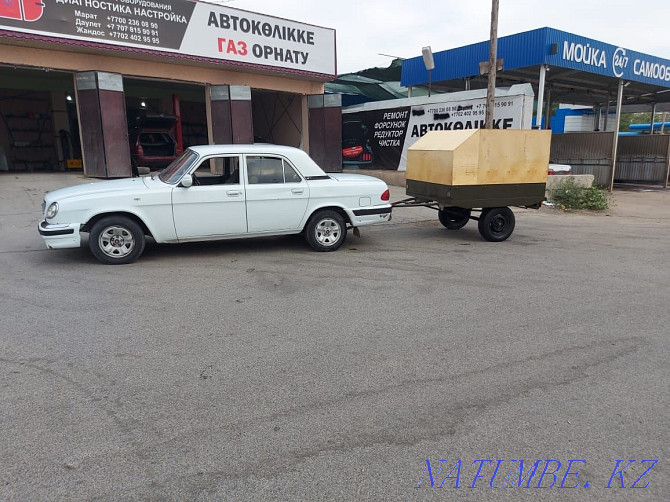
551 132 670 186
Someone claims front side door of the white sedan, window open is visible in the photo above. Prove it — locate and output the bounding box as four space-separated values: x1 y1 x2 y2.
172 155 247 240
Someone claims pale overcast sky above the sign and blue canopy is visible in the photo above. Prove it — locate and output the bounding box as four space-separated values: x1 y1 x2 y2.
207 0 670 74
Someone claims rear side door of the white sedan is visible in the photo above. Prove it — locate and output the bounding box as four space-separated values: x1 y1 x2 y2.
245 155 309 233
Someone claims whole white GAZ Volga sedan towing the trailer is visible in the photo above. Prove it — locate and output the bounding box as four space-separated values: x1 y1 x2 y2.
38 145 391 264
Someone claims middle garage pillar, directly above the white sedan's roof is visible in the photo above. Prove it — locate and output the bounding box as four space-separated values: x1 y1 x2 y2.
209 85 254 144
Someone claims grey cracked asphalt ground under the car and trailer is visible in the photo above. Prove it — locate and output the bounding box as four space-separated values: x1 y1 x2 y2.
0 174 670 501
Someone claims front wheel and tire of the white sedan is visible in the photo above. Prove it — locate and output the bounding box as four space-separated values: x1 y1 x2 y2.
88 216 145 265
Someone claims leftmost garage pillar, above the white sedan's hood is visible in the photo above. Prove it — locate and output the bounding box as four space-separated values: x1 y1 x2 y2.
75 71 132 178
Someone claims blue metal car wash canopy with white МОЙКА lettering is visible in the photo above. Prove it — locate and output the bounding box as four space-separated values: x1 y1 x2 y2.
401 28 670 106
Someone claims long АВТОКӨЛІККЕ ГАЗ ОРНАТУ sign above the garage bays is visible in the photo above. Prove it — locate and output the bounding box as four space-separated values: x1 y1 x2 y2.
0 0 336 77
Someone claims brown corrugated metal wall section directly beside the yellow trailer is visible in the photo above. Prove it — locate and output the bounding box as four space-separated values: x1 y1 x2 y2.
550 132 614 186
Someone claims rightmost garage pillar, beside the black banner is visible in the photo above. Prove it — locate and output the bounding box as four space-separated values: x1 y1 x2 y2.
307 94 342 173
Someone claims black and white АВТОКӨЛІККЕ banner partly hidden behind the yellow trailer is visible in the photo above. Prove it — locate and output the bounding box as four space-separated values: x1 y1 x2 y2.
342 84 533 171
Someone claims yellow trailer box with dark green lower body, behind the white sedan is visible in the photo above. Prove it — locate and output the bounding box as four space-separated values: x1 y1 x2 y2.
406 129 551 208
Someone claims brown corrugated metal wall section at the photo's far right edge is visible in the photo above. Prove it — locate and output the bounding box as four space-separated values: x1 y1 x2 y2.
614 134 670 183
